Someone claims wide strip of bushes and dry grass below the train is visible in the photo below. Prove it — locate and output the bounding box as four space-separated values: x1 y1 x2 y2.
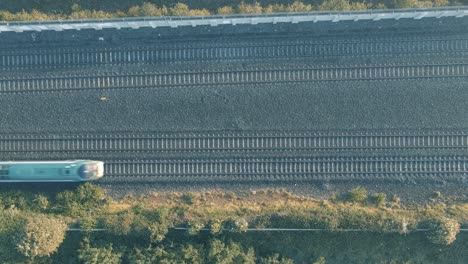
0 184 468 263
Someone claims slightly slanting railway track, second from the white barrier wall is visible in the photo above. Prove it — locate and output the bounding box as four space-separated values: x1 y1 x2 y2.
0 63 468 93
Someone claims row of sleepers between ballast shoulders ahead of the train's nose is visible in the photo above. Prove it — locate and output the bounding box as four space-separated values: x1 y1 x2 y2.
105 156 468 176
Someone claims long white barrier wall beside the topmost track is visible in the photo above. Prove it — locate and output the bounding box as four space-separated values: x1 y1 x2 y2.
0 7 468 33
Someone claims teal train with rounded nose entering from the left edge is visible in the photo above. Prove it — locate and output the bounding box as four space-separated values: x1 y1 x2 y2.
0 160 104 182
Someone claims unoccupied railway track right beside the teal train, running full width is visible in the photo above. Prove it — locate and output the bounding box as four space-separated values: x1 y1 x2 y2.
0 131 468 155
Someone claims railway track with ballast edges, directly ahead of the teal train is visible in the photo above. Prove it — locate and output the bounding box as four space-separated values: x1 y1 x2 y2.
99 156 468 182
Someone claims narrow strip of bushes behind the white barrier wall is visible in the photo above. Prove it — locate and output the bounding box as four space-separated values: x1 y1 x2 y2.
0 0 466 21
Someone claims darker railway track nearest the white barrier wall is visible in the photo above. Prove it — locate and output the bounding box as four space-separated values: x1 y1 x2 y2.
0 36 468 71
